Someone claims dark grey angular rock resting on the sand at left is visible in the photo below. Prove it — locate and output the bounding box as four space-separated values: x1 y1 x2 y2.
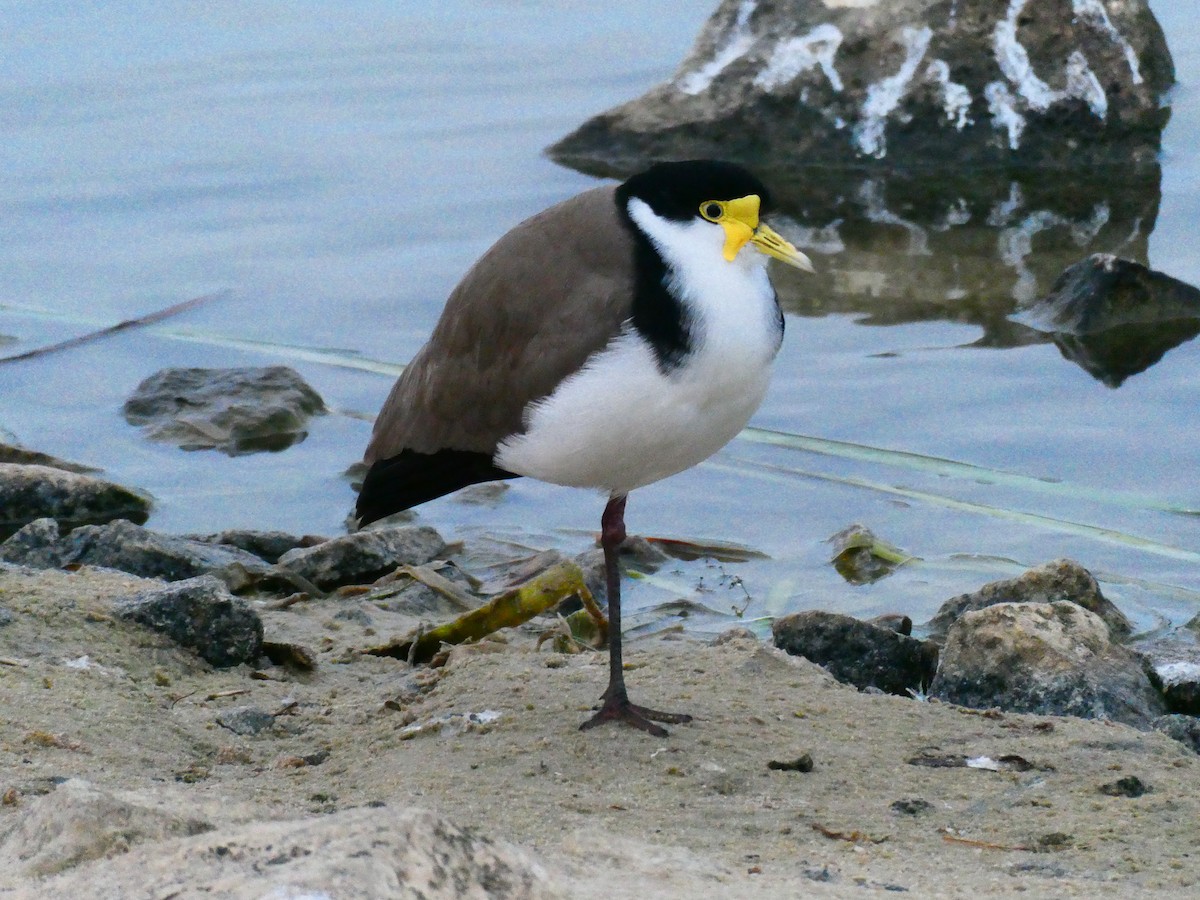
113 575 263 667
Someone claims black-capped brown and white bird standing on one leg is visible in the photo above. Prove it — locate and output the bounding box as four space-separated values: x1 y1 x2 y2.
355 160 814 737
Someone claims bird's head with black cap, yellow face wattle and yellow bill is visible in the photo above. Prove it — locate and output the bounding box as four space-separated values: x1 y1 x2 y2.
617 160 814 272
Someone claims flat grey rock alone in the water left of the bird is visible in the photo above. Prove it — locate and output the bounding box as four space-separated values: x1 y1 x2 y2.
125 366 325 456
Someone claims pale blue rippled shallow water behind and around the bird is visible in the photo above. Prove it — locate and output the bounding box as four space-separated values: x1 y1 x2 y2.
0 7 1200 629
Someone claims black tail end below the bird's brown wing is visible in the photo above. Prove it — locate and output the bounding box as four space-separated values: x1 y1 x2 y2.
355 450 518 528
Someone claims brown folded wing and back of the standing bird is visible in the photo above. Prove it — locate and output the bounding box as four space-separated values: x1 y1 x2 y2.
366 187 634 463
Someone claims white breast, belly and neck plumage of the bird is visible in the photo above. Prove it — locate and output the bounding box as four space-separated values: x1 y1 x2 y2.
496 200 781 496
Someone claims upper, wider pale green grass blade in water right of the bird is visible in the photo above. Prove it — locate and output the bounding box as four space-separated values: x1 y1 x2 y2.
738 427 1200 516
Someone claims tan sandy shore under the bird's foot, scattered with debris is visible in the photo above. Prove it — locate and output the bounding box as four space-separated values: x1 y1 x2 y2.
0 569 1200 898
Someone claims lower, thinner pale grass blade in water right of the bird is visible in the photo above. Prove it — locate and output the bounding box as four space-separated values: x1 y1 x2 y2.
707 457 1200 563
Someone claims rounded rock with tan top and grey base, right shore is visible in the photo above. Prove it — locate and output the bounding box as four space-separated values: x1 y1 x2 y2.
929 600 1165 728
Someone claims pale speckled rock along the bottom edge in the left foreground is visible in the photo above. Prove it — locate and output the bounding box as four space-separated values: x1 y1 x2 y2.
18 806 566 900
